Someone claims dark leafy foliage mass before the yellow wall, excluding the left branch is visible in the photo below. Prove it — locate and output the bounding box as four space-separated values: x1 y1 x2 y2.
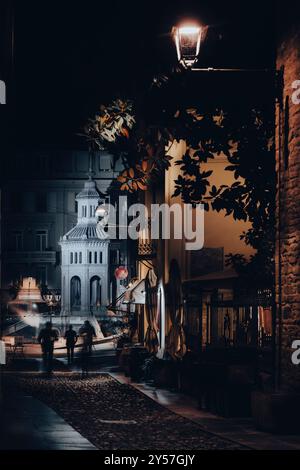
174 110 275 286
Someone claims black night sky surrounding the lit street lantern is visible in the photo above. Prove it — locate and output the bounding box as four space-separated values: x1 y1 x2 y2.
9 0 276 148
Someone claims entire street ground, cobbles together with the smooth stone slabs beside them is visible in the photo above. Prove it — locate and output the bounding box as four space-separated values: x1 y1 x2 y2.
0 345 300 450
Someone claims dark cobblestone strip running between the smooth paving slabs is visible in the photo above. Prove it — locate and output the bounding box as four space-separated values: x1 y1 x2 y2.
9 373 245 450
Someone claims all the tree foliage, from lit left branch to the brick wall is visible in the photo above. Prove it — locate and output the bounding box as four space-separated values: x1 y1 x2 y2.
85 94 275 285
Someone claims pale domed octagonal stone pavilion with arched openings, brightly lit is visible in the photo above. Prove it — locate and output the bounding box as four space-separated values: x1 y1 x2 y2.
60 179 110 315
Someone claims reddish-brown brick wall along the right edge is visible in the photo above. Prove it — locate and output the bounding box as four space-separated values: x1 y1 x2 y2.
276 21 300 391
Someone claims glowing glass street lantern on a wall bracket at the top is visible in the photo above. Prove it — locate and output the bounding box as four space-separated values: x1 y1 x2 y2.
173 23 202 68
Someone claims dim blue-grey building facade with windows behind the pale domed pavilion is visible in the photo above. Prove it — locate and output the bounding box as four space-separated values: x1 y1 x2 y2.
1 150 135 298
